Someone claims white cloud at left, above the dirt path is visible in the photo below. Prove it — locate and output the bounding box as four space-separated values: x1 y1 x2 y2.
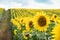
0 2 22 10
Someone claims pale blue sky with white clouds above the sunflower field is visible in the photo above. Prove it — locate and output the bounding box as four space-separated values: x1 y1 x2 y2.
0 0 60 9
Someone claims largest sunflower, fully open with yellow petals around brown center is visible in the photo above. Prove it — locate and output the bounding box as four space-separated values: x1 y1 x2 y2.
33 11 50 31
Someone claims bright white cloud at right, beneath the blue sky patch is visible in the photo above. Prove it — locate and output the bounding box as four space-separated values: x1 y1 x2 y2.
22 0 60 9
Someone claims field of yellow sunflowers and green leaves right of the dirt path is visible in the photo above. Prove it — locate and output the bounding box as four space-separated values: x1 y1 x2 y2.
10 9 60 40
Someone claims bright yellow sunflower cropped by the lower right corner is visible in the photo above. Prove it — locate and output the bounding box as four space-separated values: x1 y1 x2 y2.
51 24 60 40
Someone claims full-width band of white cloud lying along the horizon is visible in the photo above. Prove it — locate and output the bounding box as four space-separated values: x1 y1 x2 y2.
0 0 60 9
